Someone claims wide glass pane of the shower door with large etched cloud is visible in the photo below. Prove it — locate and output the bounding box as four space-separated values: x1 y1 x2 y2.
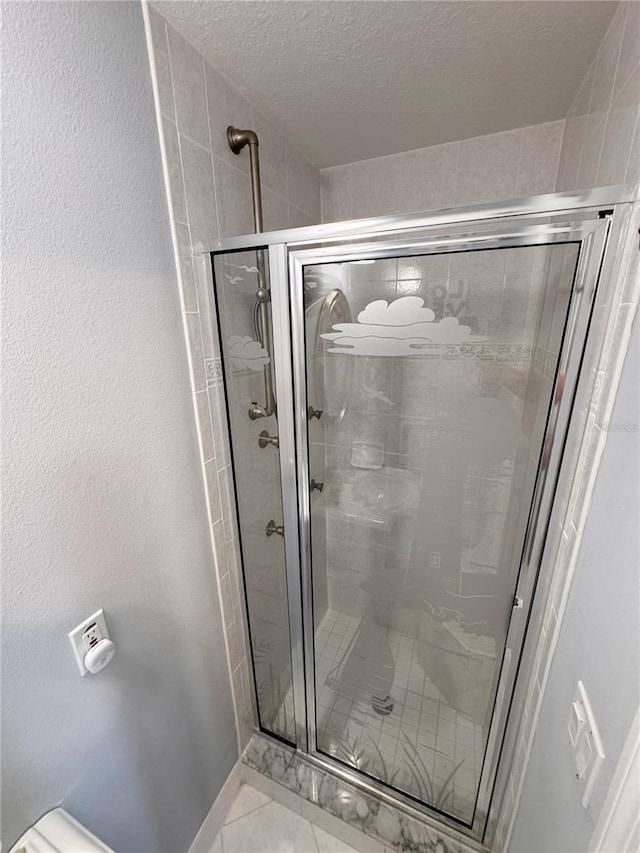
304 243 579 825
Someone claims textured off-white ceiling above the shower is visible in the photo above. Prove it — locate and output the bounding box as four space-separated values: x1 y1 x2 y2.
154 0 617 167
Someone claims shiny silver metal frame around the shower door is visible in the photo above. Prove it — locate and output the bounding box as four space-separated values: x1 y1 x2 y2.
212 187 633 839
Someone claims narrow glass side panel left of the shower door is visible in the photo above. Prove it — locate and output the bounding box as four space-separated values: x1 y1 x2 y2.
214 251 295 743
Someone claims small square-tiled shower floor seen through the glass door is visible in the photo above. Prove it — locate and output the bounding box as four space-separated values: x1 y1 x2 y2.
315 610 484 818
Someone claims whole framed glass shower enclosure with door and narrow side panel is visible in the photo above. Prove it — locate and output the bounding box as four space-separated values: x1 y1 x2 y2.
211 189 629 838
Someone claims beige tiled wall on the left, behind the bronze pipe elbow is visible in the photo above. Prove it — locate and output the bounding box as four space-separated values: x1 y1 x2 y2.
144 4 320 749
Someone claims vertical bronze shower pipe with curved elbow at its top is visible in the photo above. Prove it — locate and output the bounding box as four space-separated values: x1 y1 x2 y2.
227 125 276 420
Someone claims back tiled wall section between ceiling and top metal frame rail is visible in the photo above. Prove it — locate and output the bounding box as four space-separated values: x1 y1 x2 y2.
320 121 564 222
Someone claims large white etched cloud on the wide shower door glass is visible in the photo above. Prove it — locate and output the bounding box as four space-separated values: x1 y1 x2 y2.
322 296 486 356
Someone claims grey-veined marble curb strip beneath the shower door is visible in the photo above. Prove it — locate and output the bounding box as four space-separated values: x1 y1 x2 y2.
241 733 486 853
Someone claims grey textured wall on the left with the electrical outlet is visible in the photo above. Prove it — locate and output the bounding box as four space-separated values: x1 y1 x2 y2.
2 2 237 853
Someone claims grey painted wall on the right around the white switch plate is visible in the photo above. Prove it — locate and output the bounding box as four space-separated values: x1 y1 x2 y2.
509 318 640 853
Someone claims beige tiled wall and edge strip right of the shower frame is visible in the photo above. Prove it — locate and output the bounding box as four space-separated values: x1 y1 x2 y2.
496 2 640 850
